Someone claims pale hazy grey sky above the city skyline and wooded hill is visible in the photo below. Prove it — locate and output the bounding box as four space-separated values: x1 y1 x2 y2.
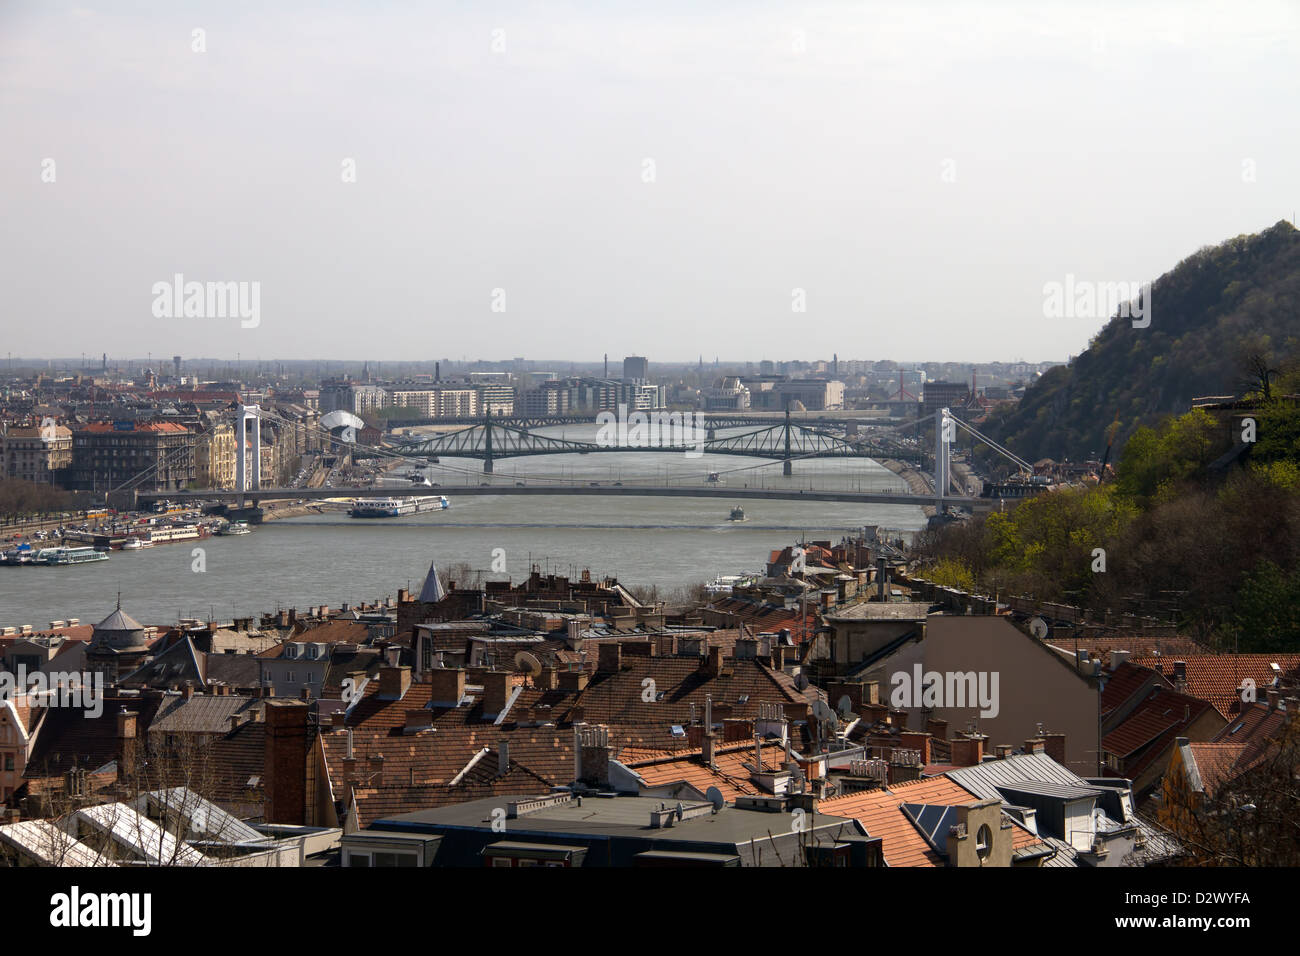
0 0 1300 362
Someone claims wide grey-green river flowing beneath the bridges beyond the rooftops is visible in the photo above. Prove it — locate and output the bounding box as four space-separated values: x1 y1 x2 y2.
0 444 924 630
